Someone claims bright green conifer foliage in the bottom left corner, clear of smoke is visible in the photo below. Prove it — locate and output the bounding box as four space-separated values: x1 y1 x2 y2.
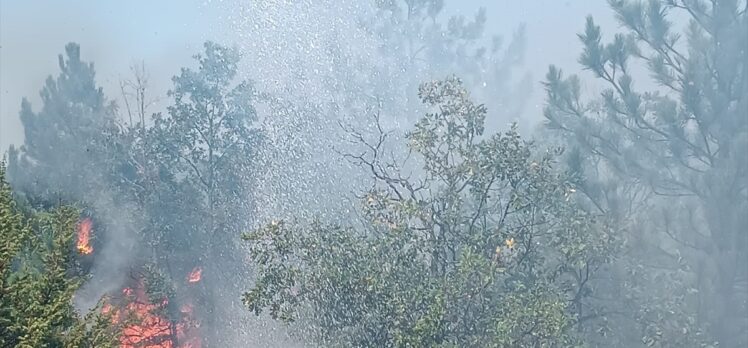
0 163 118 348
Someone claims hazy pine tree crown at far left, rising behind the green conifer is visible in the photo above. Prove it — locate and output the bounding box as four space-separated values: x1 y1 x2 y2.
8 43 121 205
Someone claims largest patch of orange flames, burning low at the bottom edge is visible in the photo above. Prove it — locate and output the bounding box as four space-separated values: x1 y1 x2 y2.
103 280 201 348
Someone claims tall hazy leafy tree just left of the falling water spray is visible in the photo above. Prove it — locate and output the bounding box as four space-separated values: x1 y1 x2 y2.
148 42 259 342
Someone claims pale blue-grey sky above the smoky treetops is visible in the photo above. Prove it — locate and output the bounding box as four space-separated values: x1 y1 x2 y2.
0 0 616 153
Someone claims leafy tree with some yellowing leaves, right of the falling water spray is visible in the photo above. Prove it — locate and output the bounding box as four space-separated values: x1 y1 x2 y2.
244 78 617 347
